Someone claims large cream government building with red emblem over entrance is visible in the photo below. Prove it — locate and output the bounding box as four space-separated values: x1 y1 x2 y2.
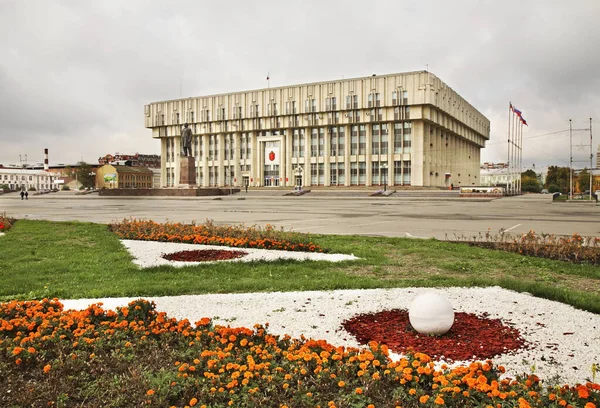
144 71 490 188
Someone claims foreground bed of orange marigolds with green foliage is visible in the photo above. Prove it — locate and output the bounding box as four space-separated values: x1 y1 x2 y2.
0 299 600 408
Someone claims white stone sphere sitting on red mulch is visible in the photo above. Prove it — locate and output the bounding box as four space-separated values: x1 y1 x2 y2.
408 292 454 336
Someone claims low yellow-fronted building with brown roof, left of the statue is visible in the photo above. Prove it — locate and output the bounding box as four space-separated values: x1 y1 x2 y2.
96 164 154 189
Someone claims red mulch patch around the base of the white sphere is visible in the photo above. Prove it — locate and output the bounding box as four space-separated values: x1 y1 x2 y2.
342 309 527 361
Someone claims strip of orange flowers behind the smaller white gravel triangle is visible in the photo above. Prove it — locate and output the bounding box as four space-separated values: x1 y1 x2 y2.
110 219 327 252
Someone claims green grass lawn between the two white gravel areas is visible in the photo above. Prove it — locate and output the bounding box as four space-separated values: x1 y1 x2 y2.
0 220 600 313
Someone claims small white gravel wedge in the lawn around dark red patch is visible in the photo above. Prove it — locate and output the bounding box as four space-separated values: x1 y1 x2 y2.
121 240 359 268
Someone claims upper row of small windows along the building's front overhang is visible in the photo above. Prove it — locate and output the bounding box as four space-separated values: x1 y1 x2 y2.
155 91 408 126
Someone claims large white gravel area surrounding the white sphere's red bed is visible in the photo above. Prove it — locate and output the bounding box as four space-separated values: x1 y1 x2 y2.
62 287 600 385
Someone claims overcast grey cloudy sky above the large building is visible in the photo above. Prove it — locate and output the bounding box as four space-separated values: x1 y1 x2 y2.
0 0 600 168
